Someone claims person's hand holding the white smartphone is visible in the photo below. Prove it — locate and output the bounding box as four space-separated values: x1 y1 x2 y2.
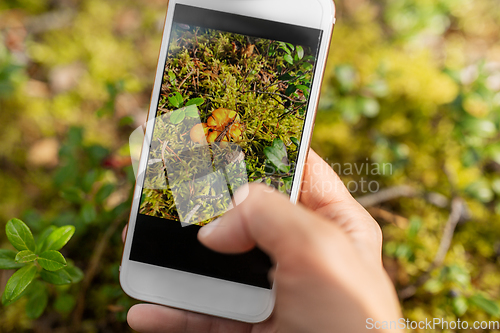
128 151 401 333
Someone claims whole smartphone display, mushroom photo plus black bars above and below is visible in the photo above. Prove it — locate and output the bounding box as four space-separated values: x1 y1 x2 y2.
130 4 322 289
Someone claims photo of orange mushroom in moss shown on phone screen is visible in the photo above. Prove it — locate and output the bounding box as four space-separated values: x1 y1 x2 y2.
140 23 316 225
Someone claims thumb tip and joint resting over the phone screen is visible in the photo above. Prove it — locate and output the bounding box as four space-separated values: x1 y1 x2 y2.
198 184 332 262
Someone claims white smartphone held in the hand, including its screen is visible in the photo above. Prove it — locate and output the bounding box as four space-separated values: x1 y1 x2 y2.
120 0 335 323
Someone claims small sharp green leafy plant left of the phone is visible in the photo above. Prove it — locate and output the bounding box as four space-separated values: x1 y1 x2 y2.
0 219 83 319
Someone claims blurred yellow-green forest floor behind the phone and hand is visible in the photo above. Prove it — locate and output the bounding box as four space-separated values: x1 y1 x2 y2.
0 0 500 332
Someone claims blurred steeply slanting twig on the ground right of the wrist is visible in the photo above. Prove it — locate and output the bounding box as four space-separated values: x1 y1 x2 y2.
399 197 464 300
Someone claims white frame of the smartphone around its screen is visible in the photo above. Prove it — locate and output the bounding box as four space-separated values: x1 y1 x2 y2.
120 0 335 323
